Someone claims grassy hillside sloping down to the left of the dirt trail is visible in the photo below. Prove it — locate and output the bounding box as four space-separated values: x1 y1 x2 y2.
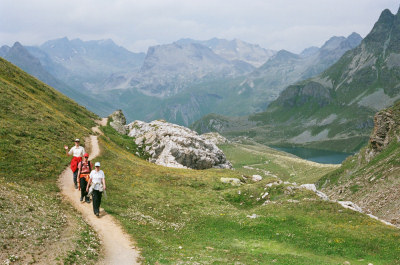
0 58 99 264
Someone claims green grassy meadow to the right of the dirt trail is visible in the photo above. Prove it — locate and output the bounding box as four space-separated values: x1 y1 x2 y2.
98 124 400 265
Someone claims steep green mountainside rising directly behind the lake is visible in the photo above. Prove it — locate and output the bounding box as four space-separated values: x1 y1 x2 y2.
194 7 400 152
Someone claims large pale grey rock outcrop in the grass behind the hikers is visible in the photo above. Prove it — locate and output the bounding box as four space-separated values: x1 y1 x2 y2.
126 120 232 169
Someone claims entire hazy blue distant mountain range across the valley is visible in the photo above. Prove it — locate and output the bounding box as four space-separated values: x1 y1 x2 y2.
0 33 361 126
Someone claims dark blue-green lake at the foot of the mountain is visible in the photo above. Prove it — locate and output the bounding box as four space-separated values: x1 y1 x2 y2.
271 146 353 164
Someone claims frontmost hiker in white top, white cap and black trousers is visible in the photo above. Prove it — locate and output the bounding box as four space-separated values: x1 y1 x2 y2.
86 162 106 217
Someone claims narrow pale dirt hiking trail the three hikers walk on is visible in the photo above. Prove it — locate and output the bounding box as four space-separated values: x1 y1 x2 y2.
59 119 140 265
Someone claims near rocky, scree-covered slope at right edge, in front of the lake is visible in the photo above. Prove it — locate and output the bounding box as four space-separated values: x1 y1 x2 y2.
318 102 400 225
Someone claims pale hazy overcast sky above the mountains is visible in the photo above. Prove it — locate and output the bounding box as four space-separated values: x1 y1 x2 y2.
0 0 400 52
